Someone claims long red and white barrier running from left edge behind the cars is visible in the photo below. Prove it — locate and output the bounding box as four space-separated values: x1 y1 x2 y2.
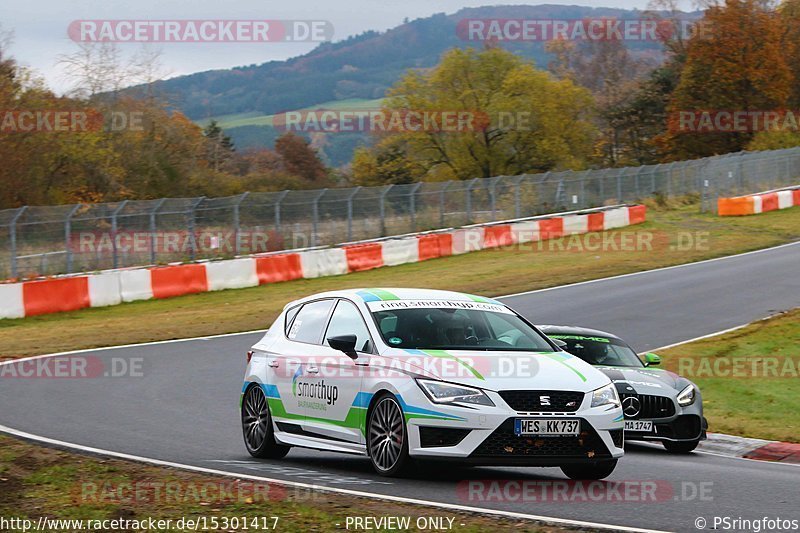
0 205 646 319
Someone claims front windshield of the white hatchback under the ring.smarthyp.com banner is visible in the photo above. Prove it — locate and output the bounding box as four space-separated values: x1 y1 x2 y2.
371 302 555 352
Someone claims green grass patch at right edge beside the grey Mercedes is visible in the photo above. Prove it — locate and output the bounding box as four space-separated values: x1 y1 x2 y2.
661 309 800 442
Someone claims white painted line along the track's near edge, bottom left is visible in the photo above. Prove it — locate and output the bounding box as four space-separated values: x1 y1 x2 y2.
0 426 666 533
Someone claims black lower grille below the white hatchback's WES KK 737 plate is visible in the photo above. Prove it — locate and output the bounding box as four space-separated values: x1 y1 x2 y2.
470 418 611 459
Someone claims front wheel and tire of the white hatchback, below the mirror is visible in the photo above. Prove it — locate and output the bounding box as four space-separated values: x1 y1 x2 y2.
366 393 412 477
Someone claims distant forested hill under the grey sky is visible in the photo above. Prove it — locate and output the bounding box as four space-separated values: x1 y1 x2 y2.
141 5 696 164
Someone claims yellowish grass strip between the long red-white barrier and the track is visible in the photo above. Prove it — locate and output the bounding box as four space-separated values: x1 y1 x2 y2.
0 205 800 357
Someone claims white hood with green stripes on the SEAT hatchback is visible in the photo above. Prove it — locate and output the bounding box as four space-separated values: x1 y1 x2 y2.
383 348 609 392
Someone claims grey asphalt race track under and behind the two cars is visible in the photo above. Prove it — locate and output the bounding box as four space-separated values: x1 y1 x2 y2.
0 243 800 531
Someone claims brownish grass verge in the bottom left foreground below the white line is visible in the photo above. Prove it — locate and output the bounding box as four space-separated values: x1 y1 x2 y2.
0 435 563 533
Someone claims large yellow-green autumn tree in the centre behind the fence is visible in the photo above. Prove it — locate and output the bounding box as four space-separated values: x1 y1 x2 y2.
354 47 595 182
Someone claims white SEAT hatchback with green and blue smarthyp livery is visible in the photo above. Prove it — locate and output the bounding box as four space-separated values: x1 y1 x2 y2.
241 289 624 479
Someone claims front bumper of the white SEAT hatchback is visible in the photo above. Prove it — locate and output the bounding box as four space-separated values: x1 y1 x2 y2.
408 391 624 466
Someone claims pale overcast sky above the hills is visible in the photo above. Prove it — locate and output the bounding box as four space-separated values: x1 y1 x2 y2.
0 0 688 92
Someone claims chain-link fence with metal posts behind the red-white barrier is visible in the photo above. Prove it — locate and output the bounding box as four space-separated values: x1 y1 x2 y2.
0 148 800 279
